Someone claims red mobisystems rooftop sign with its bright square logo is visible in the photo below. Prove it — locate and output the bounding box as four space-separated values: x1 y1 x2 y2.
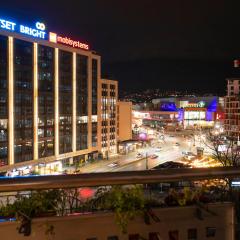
49 32 89 50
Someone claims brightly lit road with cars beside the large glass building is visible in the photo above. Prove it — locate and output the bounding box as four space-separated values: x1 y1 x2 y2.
80 134 195 173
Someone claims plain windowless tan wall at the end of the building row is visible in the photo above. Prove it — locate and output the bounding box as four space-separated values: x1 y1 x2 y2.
118 102 132 141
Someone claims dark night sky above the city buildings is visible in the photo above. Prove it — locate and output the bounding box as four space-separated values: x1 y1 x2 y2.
0 0 240 94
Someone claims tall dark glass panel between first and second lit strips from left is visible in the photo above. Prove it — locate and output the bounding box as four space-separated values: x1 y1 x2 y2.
14 39 33 163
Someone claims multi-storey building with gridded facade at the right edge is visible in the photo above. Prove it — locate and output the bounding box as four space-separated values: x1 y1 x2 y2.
224 78 240 138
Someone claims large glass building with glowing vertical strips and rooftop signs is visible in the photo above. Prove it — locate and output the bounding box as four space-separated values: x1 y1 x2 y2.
0 18 101 167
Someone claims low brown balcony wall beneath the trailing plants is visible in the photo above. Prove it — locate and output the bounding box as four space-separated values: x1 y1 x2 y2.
0 203 234 240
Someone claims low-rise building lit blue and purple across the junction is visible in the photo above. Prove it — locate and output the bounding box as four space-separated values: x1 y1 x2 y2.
133 96 224 128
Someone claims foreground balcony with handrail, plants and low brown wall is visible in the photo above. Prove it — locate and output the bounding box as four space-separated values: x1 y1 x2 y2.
0 167 237 240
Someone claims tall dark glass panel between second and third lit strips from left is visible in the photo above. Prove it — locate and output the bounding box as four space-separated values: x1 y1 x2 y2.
38 45 54 158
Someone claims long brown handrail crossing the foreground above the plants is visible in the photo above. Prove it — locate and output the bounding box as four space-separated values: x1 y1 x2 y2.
0 167 240 192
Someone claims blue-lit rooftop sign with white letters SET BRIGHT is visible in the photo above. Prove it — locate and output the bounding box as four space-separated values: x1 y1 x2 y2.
0 18 46 39
